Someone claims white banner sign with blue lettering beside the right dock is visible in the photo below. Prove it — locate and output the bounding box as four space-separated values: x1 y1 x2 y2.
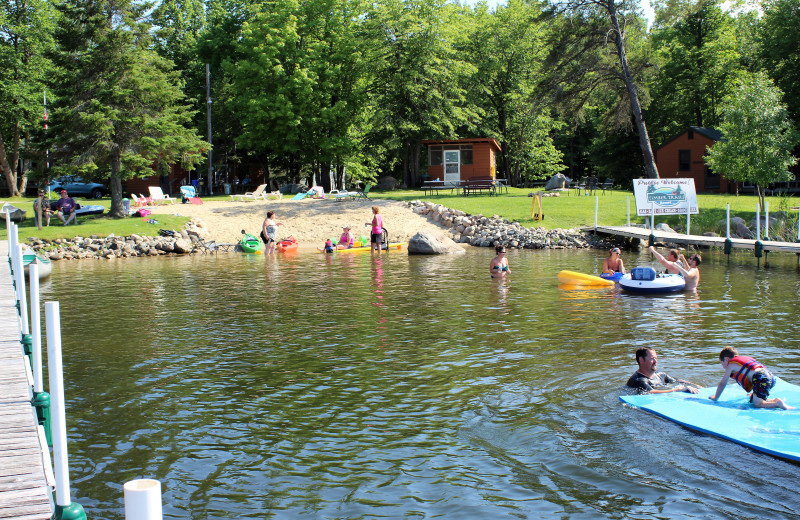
633 179 698 216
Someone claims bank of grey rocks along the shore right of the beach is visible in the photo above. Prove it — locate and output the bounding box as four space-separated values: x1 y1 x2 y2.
408 200 620 249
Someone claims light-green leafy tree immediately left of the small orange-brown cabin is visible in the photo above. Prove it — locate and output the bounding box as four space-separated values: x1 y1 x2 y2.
366 0 476 186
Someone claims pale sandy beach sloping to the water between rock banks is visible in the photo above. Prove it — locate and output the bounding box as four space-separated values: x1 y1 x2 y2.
147 197 444 249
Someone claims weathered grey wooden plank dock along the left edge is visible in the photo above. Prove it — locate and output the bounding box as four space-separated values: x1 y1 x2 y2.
0 241 53 520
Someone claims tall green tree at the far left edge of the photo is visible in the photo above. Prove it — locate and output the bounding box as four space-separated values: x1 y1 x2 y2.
0 0 53 196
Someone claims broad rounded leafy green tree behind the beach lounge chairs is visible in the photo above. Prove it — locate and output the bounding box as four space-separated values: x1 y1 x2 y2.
228 0 373 187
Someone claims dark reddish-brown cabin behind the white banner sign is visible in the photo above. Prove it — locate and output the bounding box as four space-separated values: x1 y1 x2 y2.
655 126 736 193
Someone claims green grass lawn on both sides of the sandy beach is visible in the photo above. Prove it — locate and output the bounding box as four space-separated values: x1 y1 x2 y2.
0 188 800 240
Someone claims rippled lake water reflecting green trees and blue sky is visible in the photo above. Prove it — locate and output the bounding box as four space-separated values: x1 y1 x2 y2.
37 249 800 520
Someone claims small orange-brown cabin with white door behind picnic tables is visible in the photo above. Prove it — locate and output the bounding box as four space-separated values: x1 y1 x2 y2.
422 137 500 182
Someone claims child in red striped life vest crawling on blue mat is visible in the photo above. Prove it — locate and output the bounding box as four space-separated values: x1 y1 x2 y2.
708 347 794 410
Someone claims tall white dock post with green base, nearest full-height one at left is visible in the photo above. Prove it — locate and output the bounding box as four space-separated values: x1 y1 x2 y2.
44 302 86 520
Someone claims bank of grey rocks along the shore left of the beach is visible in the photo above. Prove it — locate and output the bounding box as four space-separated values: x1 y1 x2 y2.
29 219 209 260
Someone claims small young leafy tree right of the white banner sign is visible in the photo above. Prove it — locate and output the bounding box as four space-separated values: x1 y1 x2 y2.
706 73 798 207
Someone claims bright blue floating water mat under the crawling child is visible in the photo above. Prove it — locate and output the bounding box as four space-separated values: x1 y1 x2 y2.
620 377 800 461
